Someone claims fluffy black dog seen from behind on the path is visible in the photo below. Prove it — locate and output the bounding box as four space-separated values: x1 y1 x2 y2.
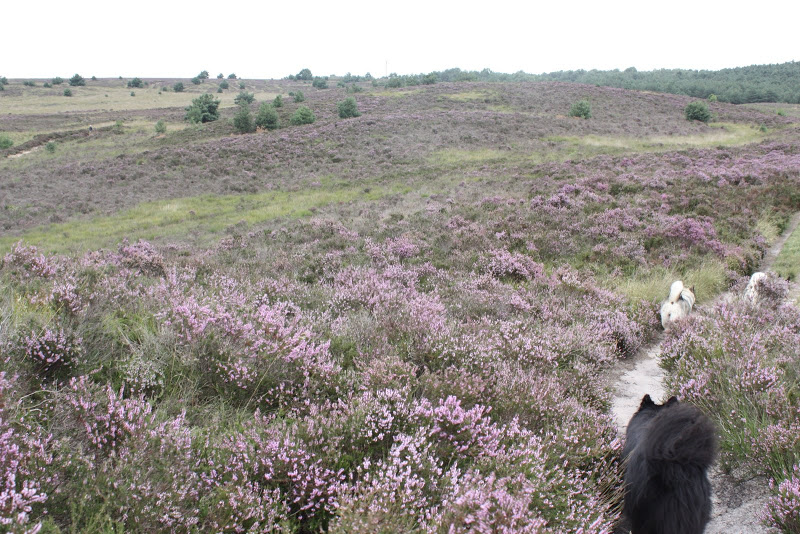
622 395 717 534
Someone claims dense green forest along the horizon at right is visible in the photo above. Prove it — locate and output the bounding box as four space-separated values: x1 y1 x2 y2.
424 61 800 104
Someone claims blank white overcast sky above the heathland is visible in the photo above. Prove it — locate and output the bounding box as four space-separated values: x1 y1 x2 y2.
6 0 800 78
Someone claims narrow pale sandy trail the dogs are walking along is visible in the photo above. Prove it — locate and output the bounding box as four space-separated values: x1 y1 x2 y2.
608 213 800 534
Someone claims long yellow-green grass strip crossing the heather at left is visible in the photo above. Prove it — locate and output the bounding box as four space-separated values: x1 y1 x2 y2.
0 184 408 253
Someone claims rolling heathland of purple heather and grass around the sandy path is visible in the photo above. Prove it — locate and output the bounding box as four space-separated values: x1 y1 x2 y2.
0 80 800 533
